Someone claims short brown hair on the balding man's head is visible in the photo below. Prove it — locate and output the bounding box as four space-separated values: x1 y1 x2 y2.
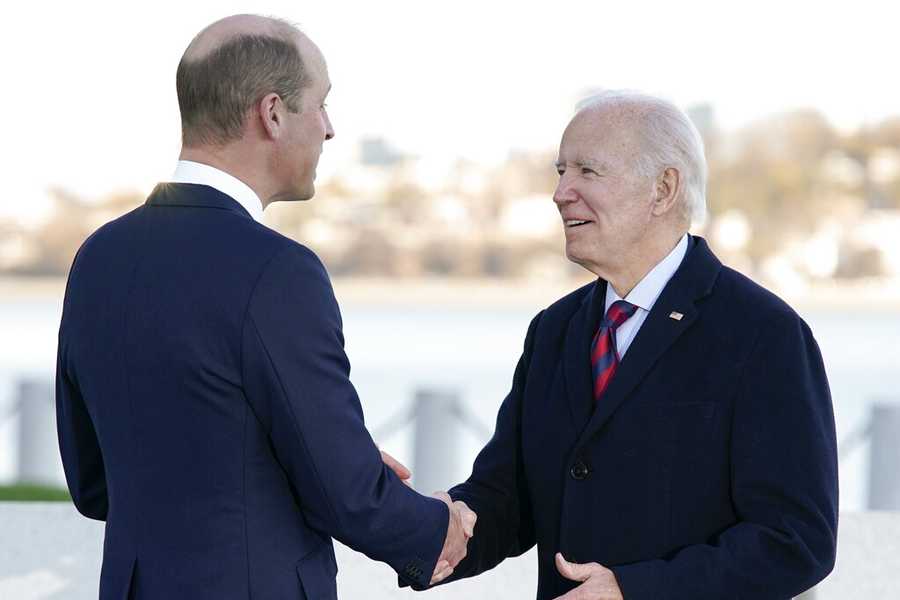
175 34 309 146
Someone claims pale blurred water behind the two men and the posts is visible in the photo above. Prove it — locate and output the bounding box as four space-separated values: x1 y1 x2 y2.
0 292 900 510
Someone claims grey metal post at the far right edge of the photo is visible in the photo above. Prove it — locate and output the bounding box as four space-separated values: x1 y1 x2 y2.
869 402 900 510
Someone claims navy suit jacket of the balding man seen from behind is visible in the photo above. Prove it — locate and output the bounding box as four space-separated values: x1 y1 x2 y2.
57 184 448 600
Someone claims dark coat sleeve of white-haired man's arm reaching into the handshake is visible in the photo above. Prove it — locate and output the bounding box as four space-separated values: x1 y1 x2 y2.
434 313 543 581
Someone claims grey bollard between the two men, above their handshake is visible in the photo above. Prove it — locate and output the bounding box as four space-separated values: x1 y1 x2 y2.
413 388 462 494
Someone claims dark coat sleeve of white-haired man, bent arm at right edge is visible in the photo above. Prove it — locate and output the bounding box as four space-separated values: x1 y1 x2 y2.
612 313 838 600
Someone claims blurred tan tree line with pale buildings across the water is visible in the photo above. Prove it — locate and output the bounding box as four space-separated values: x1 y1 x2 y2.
0 110 900 277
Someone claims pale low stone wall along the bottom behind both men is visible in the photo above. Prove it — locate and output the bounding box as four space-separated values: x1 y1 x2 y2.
0 502 900 600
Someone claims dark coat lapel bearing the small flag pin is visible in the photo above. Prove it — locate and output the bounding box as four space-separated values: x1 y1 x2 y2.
578 238 721 446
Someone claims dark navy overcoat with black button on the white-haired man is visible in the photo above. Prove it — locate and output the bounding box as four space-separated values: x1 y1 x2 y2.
442 238 838 600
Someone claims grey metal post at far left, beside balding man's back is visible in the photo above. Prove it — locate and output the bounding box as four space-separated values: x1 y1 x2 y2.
18 379 65 486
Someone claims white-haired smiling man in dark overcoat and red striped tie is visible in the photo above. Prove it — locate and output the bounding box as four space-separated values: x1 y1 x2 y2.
426 92 838 600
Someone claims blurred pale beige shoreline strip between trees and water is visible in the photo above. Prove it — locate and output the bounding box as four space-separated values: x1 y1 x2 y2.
0 276 900 313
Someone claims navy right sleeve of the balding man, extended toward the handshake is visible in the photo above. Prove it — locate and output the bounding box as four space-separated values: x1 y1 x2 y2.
242 246 449 585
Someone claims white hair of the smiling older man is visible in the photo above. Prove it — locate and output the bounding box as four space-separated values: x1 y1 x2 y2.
576 90 707 222
